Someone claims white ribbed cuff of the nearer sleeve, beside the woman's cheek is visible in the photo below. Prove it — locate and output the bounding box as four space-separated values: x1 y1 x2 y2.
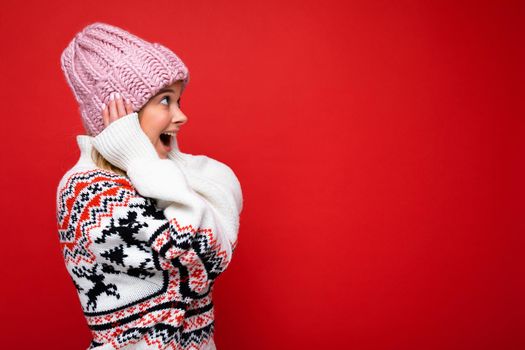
93 112 160 172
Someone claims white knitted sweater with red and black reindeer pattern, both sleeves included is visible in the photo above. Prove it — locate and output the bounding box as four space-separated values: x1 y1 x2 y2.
56 113 243 350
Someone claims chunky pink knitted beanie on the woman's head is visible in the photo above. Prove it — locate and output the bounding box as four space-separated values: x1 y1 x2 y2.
60 22 190 136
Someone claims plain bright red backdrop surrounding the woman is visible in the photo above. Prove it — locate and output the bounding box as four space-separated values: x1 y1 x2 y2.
0 0 525 350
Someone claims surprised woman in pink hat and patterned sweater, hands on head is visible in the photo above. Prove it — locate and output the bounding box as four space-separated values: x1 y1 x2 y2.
57 23 243 349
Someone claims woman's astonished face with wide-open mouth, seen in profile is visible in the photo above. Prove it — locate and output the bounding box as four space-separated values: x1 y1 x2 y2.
138 80 188 159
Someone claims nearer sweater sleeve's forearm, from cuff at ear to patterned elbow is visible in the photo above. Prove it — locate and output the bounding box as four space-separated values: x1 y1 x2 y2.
93 113 231 288
